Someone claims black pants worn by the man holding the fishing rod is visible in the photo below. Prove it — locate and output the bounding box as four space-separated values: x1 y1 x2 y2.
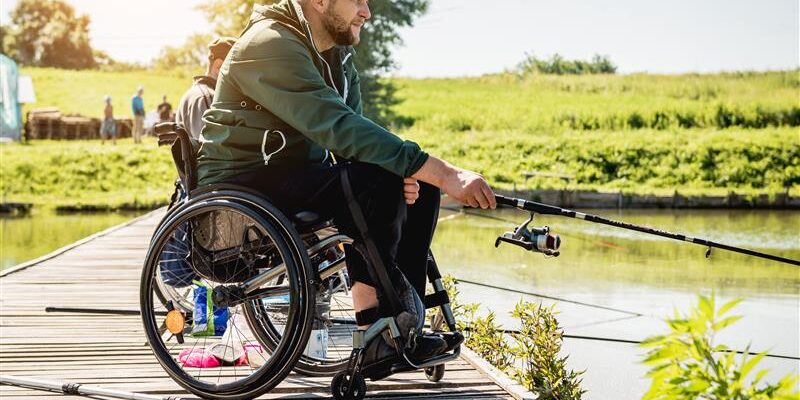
229 163 440 297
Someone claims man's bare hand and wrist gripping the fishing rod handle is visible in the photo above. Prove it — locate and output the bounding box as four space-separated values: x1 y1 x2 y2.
412 156 497 209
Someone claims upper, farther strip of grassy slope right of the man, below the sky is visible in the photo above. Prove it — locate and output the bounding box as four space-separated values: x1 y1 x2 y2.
396 71 800 133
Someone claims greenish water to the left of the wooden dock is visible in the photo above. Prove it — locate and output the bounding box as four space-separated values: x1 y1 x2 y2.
0 209 141 269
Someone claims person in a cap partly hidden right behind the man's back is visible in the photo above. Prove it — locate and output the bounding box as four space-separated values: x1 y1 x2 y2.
175 37 236 140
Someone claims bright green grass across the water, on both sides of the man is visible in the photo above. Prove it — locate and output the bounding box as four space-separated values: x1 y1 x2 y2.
10 68 800 208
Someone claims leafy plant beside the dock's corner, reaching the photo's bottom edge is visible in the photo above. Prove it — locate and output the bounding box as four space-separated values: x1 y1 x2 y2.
511 301 586 400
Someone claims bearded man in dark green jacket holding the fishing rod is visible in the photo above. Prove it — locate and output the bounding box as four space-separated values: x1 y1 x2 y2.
197 0 496 375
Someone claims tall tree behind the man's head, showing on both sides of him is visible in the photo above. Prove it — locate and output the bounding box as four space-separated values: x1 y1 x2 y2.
200 0 429 124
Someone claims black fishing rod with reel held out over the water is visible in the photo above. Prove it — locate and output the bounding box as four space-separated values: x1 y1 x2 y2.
494 195 800 266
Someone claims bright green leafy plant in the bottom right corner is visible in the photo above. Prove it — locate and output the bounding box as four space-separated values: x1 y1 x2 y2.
641 294 800 400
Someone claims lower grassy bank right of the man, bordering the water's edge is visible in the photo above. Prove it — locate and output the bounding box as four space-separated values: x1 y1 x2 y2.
405 128 800 194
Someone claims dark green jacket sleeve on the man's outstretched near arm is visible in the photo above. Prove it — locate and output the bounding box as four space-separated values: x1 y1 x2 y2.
229 35 428 176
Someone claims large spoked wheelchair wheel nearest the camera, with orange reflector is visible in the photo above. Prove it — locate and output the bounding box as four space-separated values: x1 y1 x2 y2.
140 193 316 399
